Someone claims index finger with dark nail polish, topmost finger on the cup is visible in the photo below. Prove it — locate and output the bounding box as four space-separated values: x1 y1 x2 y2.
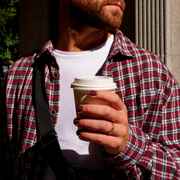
90 90 126 111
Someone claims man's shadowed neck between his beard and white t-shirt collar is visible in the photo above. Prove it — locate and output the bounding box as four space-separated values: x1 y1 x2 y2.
56 2 111 52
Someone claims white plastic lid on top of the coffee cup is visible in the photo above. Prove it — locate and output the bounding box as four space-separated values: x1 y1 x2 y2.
71 76 117 90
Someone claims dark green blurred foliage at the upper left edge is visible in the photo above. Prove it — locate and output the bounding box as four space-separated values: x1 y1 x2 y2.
0 0 19 65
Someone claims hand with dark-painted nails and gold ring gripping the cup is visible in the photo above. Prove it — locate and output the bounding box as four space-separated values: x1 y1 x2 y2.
74 91 129 154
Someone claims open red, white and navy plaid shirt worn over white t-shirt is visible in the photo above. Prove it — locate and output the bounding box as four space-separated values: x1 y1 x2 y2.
0 30 180 180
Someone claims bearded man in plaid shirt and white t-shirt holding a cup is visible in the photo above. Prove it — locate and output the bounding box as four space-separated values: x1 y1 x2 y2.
1 0 180 179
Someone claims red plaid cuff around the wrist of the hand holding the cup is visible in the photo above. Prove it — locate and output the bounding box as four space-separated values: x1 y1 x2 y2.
104 125 152 170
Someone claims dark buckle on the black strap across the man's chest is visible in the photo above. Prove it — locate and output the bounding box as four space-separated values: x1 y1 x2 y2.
39 129 58 147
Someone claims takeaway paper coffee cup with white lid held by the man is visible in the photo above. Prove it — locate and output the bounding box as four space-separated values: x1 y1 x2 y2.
71 76 117 117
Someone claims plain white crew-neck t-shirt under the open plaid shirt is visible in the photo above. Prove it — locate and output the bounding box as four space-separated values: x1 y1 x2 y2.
44 35 114 180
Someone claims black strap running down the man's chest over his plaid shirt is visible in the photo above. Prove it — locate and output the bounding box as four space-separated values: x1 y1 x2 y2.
33 53 71 179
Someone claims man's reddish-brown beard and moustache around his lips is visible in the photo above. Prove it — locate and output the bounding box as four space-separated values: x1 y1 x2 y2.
70 0 125 33
